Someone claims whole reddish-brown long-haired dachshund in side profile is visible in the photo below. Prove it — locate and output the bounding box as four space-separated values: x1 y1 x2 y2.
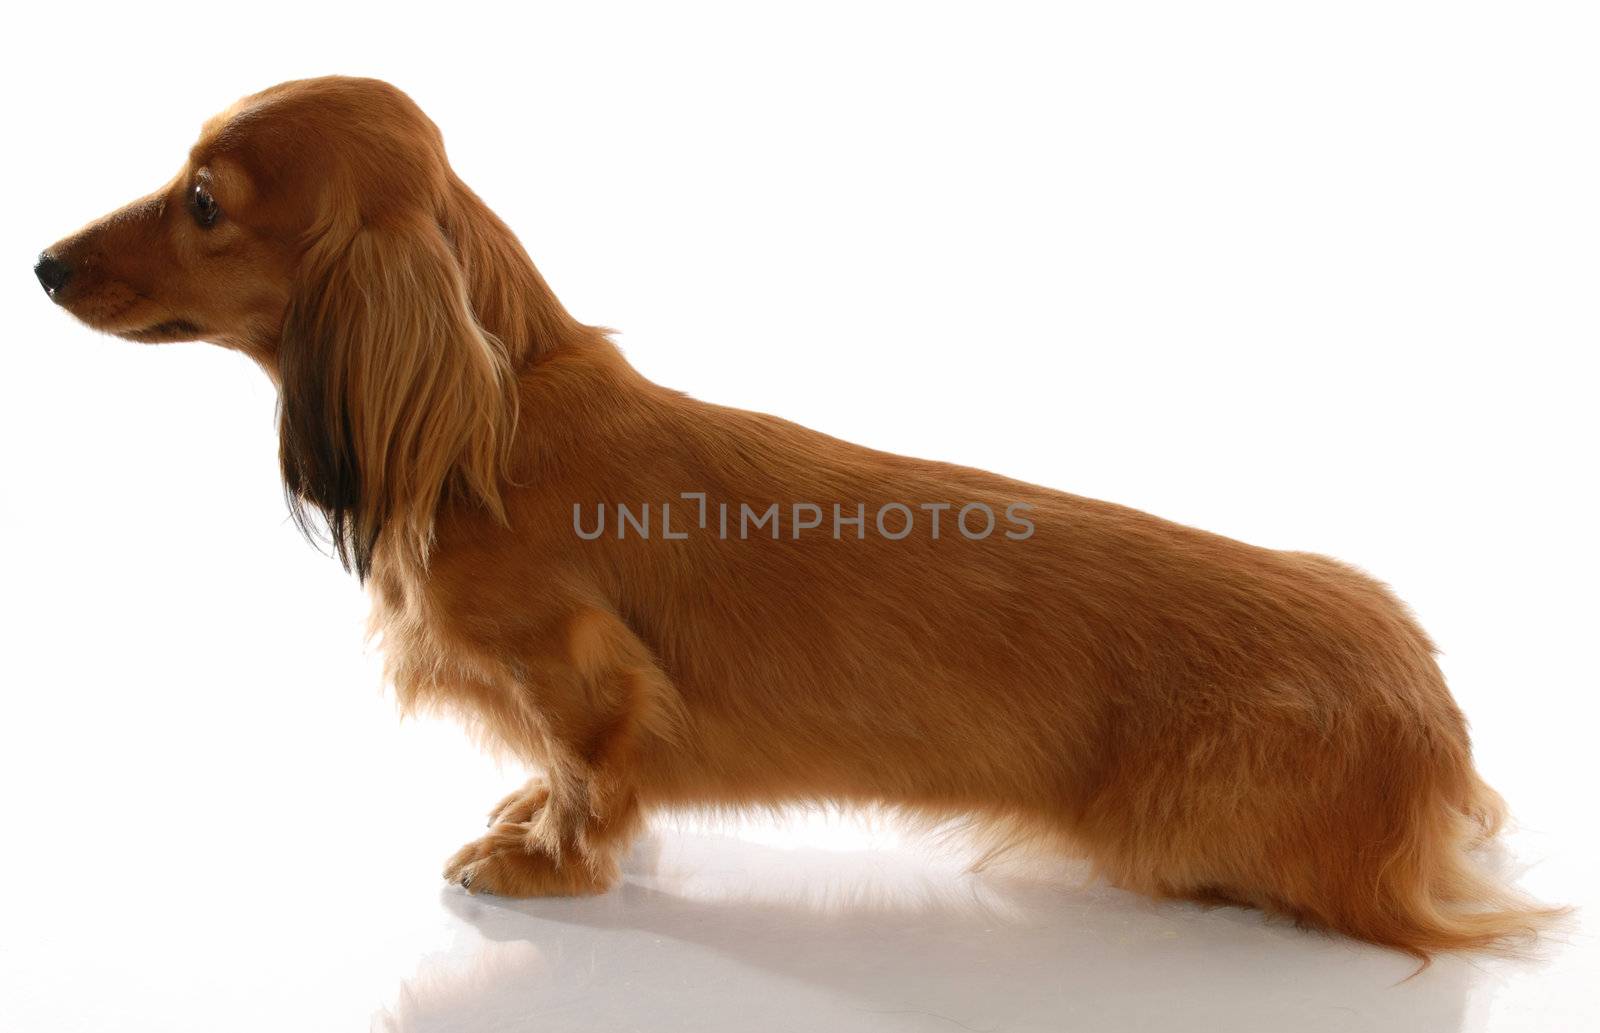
35 78 1555 959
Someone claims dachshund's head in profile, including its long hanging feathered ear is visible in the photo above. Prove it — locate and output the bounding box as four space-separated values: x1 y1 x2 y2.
35 77 547 574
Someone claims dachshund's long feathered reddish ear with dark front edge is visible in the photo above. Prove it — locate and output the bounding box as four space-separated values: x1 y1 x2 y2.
278 219 517 580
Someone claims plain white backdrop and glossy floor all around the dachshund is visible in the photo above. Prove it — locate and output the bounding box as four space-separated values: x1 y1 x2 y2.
0 0 1600 1033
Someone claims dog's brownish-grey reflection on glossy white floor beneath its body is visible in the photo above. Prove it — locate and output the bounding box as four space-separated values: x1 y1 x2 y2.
374 830 1548 1033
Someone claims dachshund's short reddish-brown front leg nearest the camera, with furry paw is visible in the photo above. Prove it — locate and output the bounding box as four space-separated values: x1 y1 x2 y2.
445 608 682 897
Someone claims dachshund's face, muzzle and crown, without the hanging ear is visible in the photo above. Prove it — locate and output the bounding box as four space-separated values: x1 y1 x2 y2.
35 78 459 363
